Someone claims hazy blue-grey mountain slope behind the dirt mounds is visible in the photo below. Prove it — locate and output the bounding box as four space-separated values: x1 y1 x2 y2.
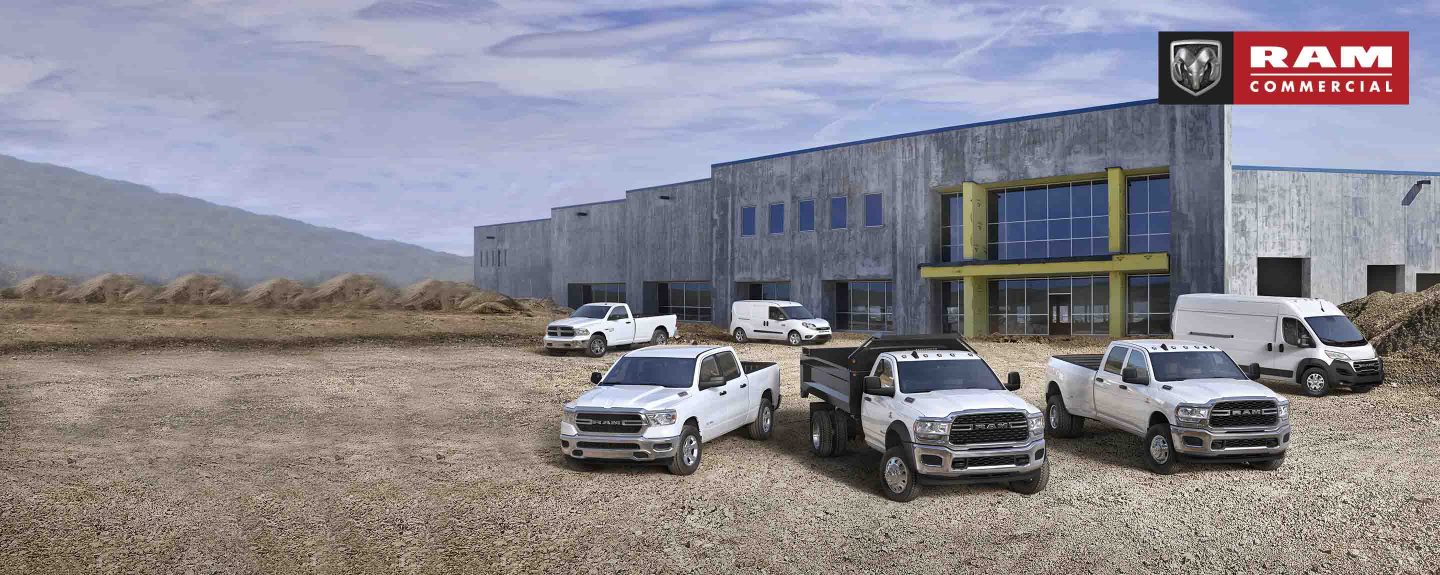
0 156 474 288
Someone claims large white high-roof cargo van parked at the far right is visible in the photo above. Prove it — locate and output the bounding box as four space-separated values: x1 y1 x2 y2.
1171 294 1385 396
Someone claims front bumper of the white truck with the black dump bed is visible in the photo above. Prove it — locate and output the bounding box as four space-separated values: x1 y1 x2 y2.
910 438 1048 483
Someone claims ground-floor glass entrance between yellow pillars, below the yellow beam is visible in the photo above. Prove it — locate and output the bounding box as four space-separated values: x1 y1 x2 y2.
988 275 1110 336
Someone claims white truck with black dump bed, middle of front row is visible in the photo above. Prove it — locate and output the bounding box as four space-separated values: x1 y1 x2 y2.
801 336 1050 502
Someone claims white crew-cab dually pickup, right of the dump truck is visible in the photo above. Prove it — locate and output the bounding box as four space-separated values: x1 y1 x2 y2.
1045 340 1290 474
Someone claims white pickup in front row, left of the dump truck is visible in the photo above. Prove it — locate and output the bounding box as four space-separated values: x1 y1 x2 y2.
560 346 780 476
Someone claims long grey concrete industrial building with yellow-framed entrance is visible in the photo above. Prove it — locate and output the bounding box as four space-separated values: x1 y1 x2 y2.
475 101 1440 337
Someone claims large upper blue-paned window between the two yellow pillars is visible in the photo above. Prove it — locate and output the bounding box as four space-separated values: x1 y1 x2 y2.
988 180 1110 259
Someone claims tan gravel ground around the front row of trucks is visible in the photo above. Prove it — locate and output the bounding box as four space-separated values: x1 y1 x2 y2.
0 343 1440 574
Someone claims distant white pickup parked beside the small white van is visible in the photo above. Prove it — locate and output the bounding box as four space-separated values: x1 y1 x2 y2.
544 304 677 357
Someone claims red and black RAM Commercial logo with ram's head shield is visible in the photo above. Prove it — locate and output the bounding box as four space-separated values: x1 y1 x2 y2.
1159 32 1410 105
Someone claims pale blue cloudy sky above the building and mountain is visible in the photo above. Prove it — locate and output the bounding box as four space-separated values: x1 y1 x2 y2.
0 0 1440 255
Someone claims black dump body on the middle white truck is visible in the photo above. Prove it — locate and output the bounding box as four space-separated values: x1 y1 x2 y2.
801 334 975 415
